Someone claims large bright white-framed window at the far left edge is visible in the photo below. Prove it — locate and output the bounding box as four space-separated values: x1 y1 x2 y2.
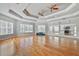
0 20 13 35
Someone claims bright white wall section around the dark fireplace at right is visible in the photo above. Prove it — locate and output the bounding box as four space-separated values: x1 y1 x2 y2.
60 24 77 36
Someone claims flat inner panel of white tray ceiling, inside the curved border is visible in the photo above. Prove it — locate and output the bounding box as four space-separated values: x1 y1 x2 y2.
0 3 70 16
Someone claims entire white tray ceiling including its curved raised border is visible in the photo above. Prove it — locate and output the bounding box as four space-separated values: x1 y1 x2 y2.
0 3 79 21
